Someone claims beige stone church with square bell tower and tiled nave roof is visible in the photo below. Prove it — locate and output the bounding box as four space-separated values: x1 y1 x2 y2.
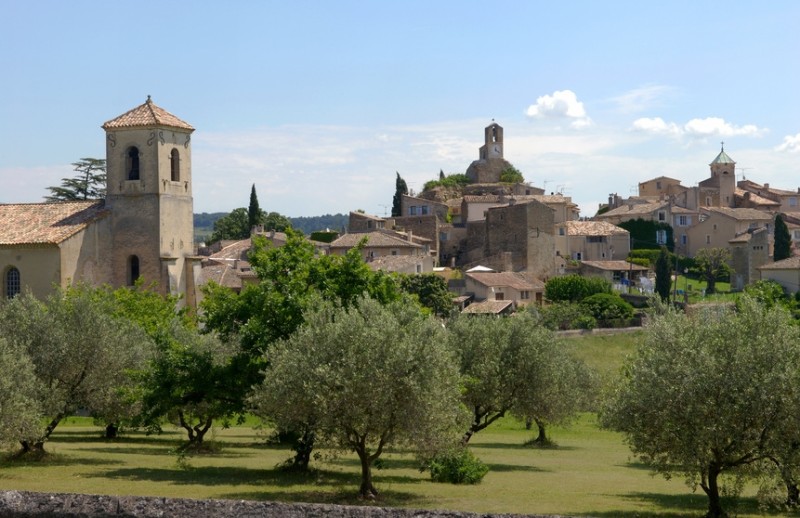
0 96 200 305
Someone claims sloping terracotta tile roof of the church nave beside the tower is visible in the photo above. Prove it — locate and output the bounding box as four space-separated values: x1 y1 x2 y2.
0 200 108 245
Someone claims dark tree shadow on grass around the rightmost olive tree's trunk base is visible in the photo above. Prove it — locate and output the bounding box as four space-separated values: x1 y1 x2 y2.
589 492 772 518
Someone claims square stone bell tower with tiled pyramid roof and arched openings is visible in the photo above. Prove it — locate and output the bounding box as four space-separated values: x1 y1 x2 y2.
102 96 194 304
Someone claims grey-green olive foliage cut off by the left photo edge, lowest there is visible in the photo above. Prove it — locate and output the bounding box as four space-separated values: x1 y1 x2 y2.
0 336 42 445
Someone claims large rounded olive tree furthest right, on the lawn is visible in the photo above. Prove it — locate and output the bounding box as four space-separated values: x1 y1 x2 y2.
601 297 800 517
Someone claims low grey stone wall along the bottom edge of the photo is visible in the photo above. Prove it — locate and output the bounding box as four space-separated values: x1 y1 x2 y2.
0 491 576 518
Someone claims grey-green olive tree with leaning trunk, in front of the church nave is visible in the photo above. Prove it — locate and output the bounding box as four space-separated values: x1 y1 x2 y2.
0 286 152 452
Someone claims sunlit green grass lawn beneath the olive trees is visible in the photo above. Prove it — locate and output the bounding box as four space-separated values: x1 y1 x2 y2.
0 332 782 518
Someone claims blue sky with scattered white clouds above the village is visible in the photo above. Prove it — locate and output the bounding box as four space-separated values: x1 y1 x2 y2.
0 0 800 217
